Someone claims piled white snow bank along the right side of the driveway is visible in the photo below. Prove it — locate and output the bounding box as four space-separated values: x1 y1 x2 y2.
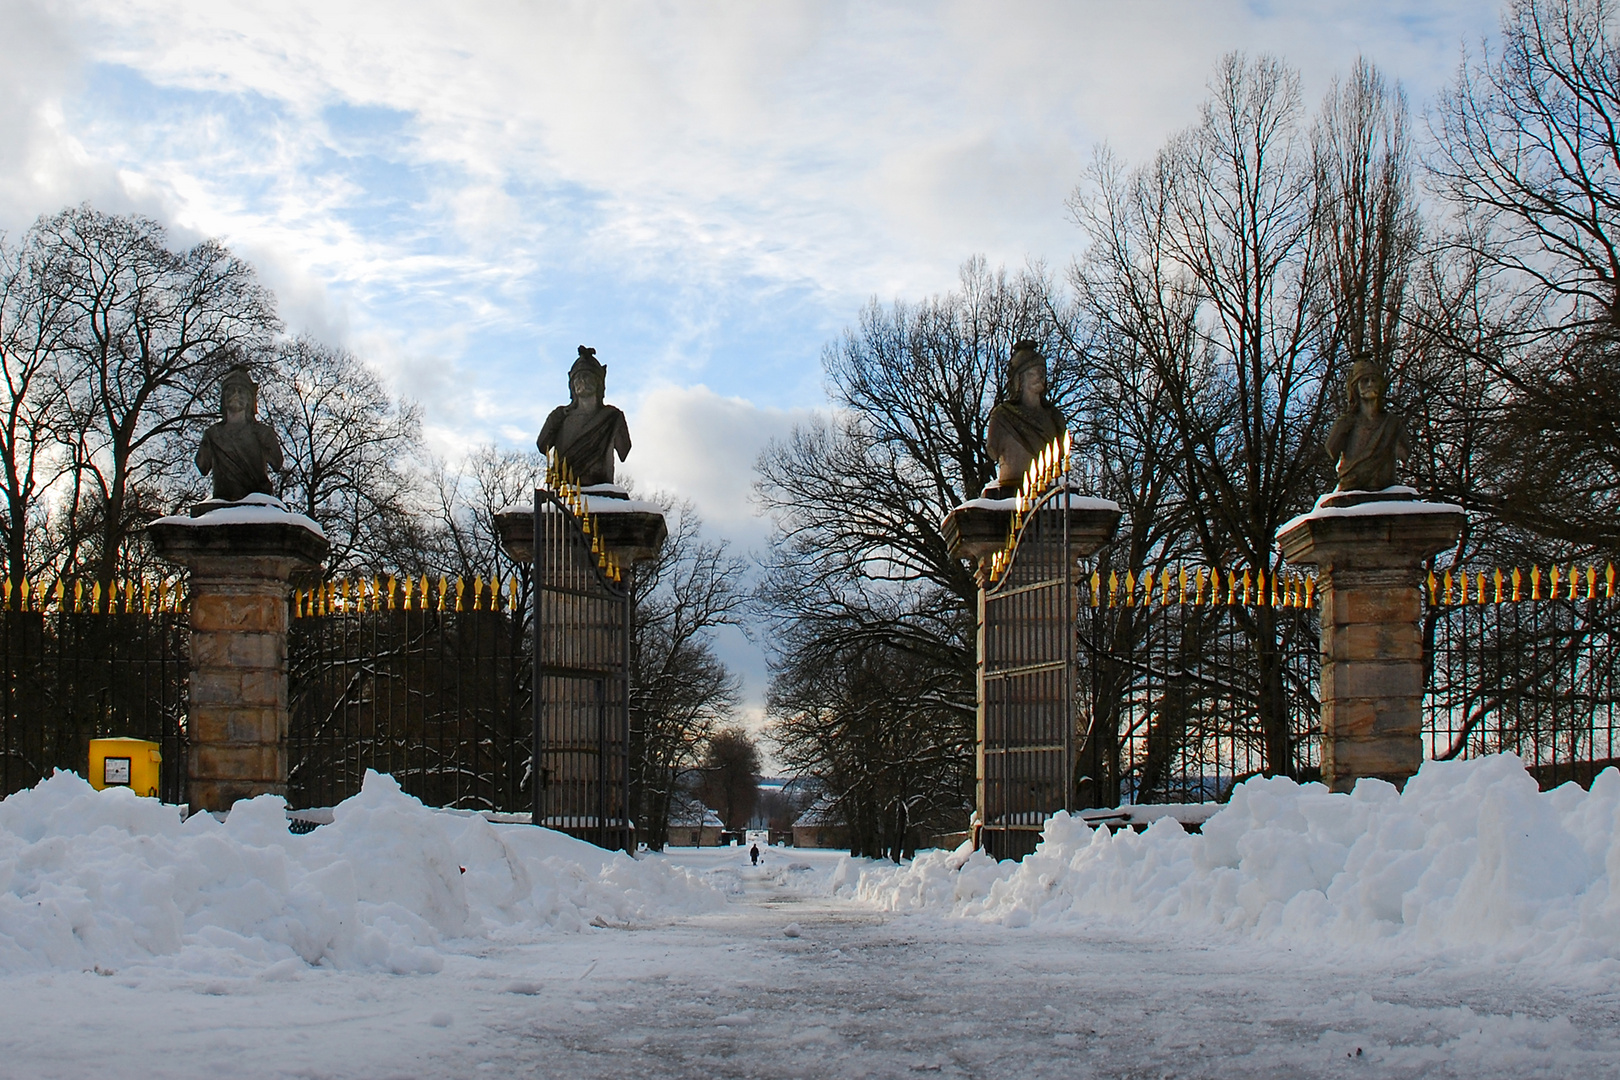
833 755 1620 962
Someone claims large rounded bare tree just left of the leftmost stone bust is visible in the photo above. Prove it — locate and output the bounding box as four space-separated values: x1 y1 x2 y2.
32 206 277 581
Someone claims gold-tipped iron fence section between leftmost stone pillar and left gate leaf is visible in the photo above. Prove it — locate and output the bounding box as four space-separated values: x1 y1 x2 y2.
287 576 533 813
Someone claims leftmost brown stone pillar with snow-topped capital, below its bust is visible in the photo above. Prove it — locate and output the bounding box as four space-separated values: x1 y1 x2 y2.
147 497 329 813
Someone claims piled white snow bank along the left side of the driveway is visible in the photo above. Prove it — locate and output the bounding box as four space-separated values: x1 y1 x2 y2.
0 772 724 973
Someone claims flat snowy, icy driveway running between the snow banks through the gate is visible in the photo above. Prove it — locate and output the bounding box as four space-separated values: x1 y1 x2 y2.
0 850 1620 1080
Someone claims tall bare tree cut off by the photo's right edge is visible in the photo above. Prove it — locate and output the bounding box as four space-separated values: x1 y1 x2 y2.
1430 0 1620 557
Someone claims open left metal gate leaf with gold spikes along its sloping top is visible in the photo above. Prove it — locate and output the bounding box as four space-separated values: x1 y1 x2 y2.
533 479 635 852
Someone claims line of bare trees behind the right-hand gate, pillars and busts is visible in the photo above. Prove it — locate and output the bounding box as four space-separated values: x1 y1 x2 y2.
758 0 1620 857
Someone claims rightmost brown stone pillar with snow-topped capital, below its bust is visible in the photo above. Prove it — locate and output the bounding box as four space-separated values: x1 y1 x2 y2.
1277 495 1464 792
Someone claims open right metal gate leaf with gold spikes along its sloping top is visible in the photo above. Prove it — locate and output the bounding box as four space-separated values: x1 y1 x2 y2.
978 484 1079 858
